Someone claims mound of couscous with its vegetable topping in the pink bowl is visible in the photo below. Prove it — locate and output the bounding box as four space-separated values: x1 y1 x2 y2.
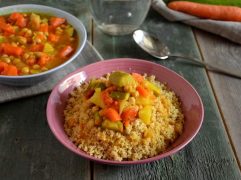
64 71 184 161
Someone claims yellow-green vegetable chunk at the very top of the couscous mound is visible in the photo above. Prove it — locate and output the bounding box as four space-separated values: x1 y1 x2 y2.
109 71 136 87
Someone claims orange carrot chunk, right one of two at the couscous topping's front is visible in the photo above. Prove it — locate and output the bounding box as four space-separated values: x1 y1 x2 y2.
121 107 138 126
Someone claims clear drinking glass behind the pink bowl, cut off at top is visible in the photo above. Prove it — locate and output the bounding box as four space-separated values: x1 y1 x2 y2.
89 0 151 35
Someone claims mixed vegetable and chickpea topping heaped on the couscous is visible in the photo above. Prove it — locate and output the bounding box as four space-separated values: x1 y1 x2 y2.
85 71 161 132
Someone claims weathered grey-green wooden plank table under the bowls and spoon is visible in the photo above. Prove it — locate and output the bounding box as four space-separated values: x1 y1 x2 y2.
0 0 241 180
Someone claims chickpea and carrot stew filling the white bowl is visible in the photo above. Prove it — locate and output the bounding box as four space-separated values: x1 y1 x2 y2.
0 12 78 76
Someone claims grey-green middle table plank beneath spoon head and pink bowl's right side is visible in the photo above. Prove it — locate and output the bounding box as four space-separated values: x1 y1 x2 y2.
93 8 241 180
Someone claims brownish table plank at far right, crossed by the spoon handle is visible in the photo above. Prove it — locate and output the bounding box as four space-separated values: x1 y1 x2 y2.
196 28 241 164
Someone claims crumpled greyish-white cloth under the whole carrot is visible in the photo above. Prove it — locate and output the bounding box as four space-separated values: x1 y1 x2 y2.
152 0 241 44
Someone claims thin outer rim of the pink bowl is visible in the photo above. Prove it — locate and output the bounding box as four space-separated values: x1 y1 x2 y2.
46 58 204 165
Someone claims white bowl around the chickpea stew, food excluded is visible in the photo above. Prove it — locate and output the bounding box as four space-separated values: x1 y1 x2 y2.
0 4 87 86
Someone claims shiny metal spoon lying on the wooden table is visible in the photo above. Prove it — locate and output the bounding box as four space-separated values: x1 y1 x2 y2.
133 29 241 78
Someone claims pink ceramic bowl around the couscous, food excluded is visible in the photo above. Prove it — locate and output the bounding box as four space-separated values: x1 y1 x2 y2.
47 58 204 165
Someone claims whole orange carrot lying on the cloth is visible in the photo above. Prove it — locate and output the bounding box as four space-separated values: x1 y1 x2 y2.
168 1 241 22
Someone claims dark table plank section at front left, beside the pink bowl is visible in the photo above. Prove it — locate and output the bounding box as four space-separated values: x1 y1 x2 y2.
0 94 90 180
